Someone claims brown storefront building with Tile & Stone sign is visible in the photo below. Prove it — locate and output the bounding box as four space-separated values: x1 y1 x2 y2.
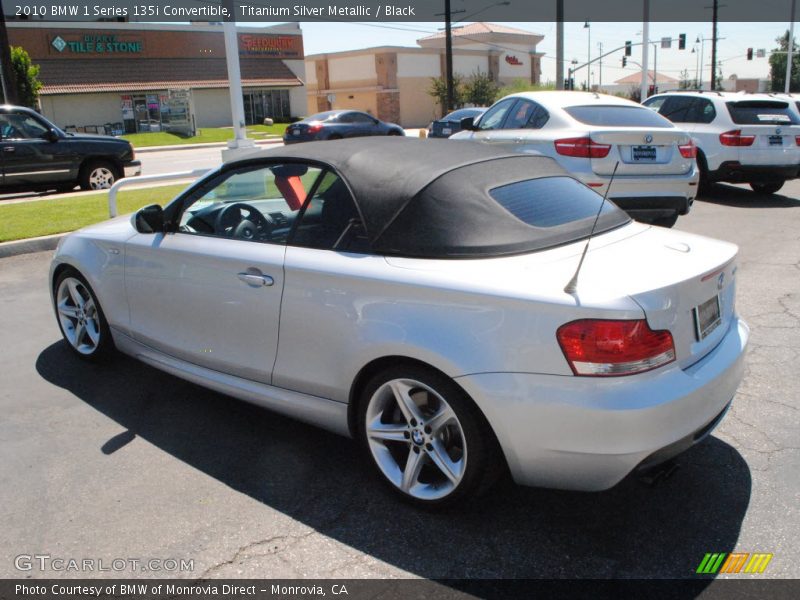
7 22 306 133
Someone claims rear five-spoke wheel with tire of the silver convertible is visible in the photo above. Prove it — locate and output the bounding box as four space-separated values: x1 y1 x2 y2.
359 366 504 507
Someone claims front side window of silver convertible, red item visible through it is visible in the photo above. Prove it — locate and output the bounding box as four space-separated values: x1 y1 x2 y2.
178 163 322 244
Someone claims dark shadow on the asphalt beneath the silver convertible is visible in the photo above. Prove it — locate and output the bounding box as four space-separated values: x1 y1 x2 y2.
36 342 751 579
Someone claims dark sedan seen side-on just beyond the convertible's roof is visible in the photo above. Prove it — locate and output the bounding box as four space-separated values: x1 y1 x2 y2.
283 110 406 144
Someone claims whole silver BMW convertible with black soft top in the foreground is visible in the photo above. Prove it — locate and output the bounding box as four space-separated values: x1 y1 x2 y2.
50 138 748 506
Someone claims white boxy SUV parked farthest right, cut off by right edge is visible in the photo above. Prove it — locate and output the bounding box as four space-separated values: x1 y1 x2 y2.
644 91 800 194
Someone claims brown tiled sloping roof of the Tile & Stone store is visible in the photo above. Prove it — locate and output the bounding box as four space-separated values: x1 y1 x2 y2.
38 58 302 95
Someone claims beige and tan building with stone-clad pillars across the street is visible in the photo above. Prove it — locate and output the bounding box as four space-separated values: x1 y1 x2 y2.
306 23 544 127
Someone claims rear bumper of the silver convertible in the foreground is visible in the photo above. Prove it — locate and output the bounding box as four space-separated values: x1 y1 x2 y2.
456 318 749 491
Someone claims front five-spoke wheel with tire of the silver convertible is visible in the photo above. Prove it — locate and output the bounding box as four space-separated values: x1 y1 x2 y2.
54 269 114 360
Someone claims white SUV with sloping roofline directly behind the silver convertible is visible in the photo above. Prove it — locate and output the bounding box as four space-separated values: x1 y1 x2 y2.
450 92 698 227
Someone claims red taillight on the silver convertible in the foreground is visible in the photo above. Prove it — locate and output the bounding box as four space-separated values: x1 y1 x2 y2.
556 319 675 377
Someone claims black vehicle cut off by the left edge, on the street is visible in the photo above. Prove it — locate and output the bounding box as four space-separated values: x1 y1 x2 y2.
0 105 142 193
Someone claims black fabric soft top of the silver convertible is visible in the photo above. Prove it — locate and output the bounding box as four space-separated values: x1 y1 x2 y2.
226 137 628 257
